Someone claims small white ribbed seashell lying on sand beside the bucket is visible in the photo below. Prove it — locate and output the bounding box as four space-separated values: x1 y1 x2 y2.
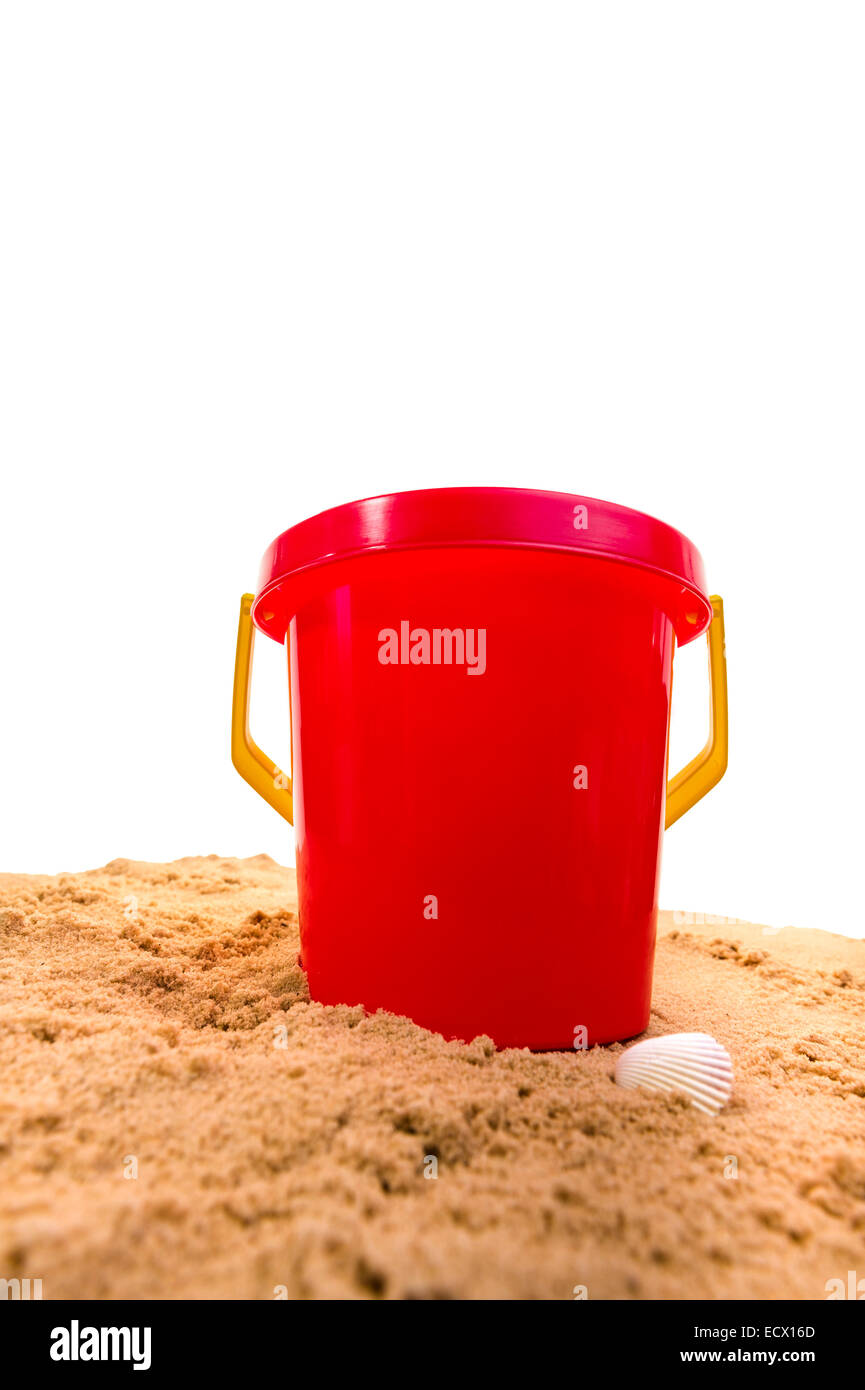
616 1033 733 1115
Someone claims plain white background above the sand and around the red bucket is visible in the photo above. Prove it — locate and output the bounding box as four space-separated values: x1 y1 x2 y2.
0 0 865 935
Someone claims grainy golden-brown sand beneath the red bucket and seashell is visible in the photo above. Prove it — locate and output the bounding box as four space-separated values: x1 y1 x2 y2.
0 856 865 1300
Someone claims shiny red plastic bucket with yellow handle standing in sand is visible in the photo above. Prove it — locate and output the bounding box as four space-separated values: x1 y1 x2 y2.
232 488 726 1048
